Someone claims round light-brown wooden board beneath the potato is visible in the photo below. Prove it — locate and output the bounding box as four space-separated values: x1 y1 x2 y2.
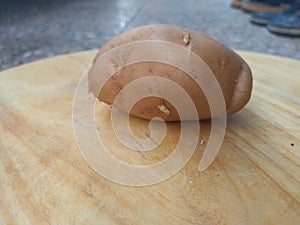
0 51 300 225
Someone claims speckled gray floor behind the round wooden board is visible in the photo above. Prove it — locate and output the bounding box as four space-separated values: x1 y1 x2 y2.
0 0 300 70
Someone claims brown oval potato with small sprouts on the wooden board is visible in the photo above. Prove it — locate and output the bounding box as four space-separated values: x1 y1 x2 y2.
88 24 252 121
